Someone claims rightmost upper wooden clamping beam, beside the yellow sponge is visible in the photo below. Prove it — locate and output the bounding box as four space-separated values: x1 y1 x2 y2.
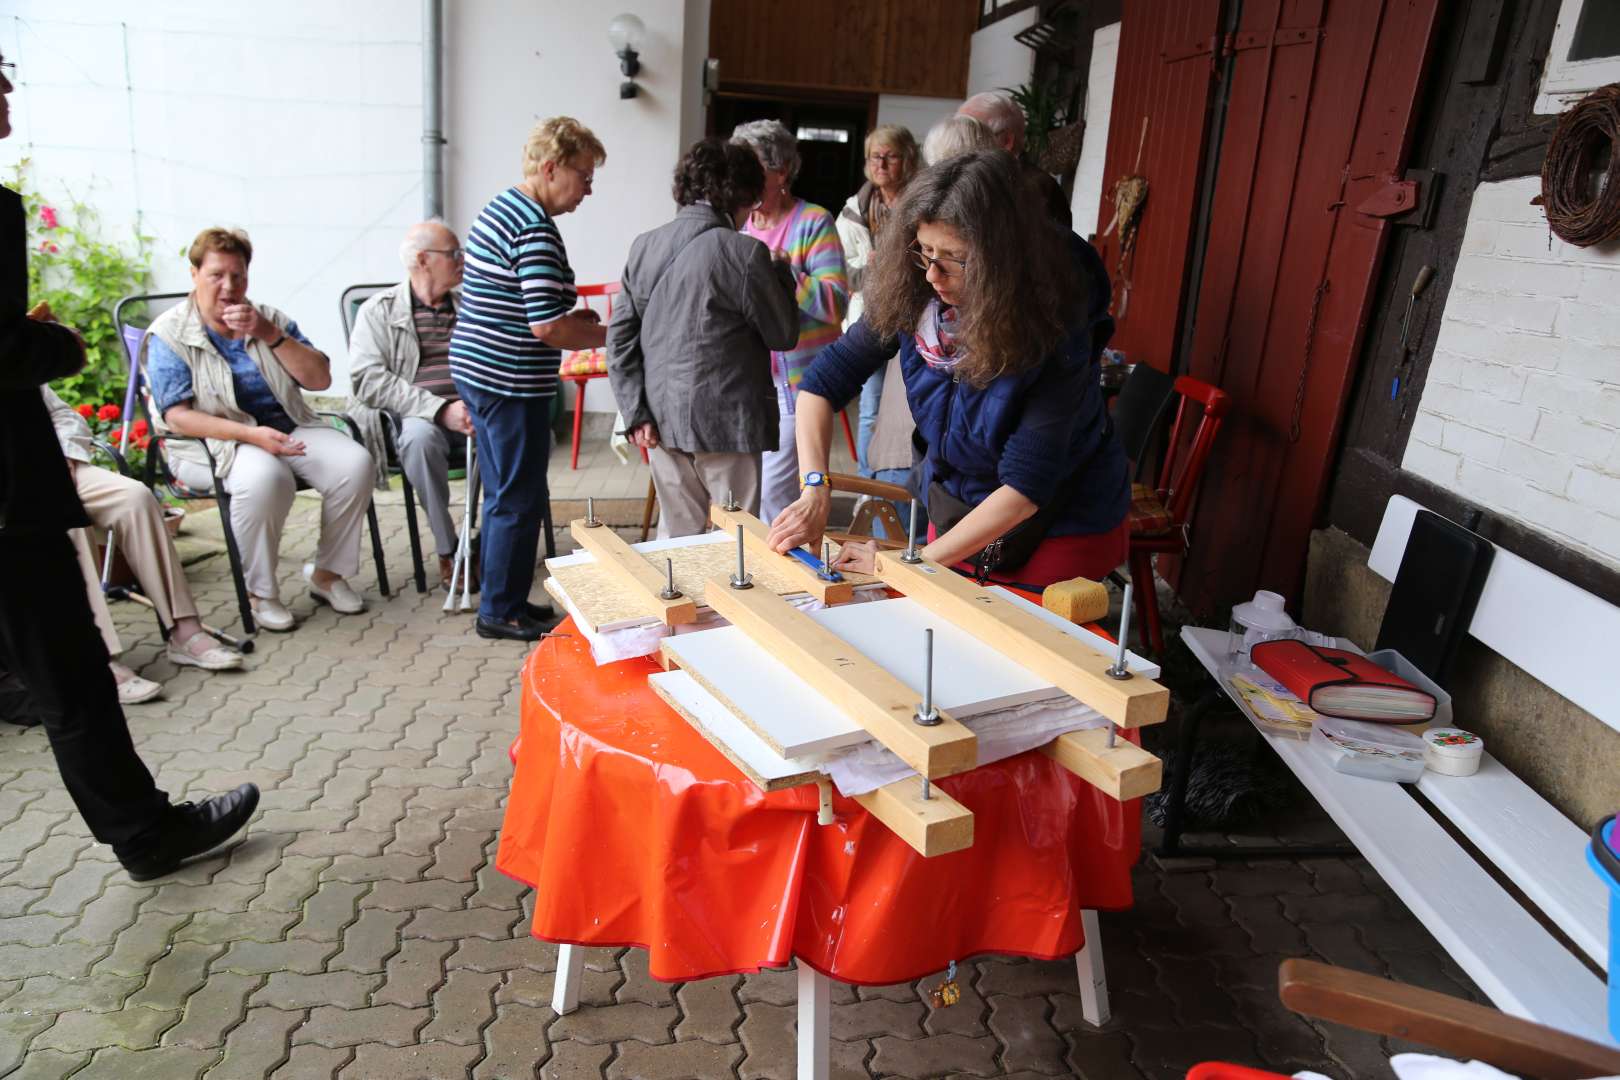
878 551 1170 727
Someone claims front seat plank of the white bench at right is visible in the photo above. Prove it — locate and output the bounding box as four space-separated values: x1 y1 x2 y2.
1181 627 1614 1046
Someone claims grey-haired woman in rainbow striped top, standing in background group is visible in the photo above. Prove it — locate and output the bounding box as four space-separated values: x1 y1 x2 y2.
731 120 849 521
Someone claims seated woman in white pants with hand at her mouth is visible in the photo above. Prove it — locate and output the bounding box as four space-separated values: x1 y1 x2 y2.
143 228 374 630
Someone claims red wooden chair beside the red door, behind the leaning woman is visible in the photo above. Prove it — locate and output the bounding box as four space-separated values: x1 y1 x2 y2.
1129 376 1231 654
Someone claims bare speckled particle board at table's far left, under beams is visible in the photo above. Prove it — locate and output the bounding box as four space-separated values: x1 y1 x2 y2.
546 529 835 631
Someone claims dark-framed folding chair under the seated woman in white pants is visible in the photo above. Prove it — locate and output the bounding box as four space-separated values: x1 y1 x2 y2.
112 293 390 638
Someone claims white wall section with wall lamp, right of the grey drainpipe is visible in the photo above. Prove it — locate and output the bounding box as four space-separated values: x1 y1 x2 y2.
444 0 708 411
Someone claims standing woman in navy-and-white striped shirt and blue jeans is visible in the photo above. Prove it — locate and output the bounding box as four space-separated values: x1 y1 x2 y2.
450 117 608 641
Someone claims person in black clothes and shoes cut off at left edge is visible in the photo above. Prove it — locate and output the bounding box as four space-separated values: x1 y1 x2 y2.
0 57 259 881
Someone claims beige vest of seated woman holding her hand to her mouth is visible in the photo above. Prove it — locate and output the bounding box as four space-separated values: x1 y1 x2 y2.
141 296 321 479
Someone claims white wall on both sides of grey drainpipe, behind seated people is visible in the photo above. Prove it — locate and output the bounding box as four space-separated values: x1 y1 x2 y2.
0 0 710 408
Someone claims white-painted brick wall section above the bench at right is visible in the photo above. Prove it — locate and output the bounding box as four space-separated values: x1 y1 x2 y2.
1401 176 1620 567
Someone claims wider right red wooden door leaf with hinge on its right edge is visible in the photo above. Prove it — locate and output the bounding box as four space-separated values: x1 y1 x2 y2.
1179 0 1440 612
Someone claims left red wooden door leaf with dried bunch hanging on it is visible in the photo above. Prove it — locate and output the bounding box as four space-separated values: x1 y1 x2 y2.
1097 0 1221 371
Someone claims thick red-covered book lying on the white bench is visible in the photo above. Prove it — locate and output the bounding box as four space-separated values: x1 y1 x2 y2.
1249 641 1435 724
